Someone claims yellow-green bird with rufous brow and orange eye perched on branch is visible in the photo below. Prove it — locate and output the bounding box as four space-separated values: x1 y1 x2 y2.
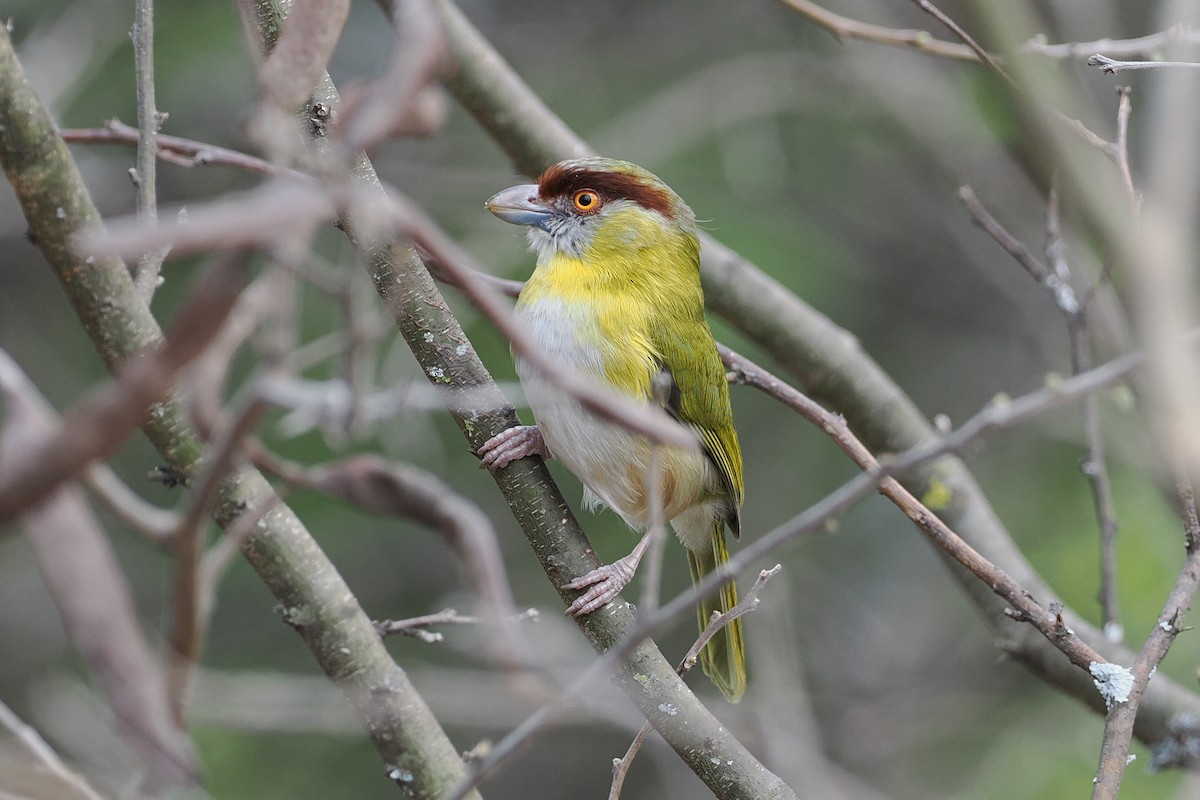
476 157 746 703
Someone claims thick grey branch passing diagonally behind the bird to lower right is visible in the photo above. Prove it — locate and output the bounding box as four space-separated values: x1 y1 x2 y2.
429 0 1200 762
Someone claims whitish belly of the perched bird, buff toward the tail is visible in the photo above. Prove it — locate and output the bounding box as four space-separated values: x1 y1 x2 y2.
516 301 714 545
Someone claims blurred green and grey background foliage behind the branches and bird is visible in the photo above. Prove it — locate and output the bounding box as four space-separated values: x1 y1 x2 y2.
0 0 1200 800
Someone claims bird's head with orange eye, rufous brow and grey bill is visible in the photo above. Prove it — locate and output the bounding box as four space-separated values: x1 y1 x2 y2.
487 157 698 261
